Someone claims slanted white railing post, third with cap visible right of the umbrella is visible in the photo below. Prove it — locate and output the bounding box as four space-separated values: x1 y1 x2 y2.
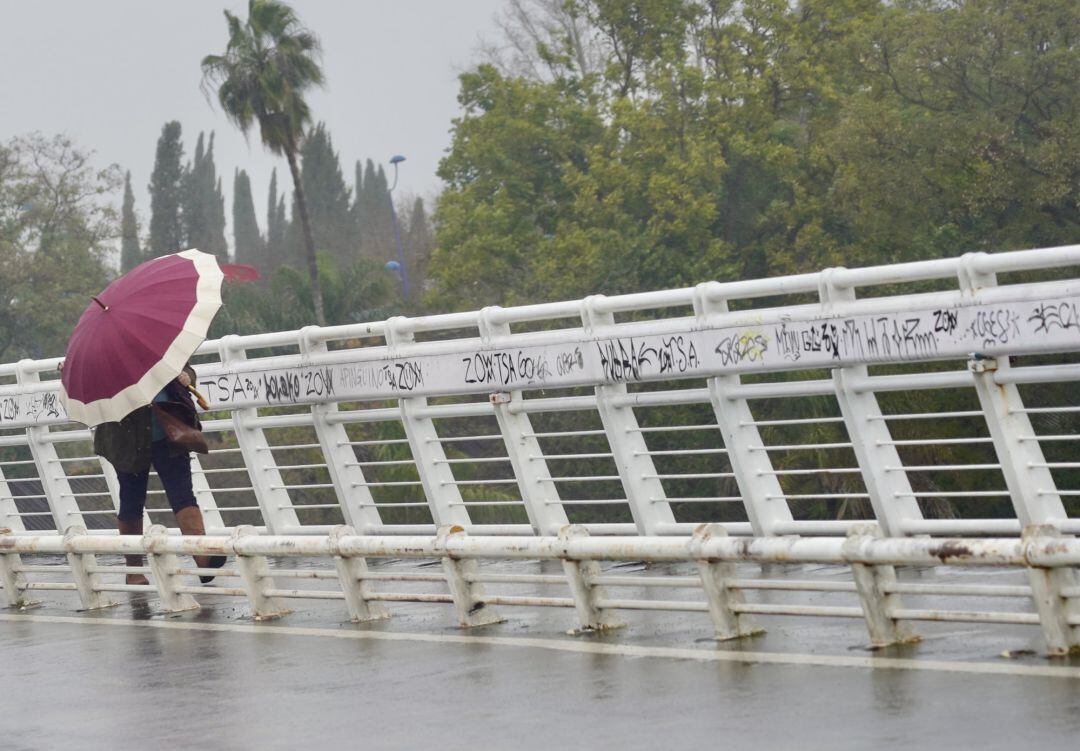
387 316 471 526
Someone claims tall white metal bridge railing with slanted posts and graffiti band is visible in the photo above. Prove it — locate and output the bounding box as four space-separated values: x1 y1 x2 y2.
0 245 1080 537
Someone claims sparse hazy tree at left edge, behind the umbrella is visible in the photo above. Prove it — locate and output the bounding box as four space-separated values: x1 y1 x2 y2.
0 134 123 362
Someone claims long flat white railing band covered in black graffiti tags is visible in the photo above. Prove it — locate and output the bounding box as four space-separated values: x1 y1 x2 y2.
6 291 1080 427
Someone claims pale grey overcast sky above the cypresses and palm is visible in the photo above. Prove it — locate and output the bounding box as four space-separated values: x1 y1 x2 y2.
0 0 503 232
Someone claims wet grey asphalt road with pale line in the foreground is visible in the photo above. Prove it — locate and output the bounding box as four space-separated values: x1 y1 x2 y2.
6 561 1080 751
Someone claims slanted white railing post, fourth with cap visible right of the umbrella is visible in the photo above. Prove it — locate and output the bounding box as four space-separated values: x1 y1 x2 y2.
480 306 569 535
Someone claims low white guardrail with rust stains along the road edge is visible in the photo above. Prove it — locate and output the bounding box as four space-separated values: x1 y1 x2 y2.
0 524 1080 655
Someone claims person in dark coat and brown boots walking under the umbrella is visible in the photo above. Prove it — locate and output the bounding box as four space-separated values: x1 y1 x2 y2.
94 365 226 585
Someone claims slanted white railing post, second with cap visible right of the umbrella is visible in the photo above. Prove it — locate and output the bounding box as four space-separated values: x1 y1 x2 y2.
300 326 382 531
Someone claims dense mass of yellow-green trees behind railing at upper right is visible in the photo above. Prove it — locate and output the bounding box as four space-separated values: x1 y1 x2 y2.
431 0 1080 308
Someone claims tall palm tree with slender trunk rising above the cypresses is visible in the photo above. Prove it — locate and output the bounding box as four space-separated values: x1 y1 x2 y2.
202 0 326 325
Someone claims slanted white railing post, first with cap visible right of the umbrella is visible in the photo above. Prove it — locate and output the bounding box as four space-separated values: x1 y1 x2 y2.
220 334 300 535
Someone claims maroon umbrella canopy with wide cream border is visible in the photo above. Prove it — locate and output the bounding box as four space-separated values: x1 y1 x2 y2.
60 250 225 426
